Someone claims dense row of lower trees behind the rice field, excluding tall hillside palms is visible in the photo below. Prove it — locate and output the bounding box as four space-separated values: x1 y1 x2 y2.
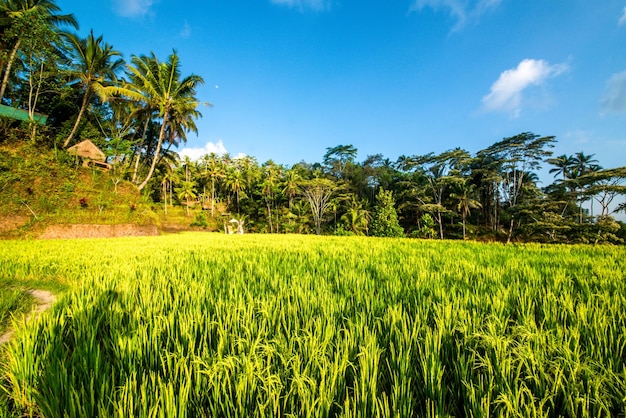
152 140 626 243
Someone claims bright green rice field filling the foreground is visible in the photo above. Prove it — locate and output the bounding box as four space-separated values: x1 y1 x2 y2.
0 233 626 417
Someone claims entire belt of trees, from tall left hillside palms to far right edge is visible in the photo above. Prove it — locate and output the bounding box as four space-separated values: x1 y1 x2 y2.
0 0 626 243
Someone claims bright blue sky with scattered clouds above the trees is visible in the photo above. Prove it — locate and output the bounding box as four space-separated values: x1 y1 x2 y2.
57 0 626 173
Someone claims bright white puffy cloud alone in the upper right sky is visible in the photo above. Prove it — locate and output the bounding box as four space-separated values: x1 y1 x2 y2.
482 59 569 117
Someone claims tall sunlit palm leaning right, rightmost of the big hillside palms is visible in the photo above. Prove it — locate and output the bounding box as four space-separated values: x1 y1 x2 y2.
118 51 204 190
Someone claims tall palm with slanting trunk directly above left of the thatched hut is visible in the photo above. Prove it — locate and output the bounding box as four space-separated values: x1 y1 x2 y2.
63 30 124 148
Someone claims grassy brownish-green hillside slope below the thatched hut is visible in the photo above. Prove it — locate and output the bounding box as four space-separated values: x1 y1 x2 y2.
0 142 160 238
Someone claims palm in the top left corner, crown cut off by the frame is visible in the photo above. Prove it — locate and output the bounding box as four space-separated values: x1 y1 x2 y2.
0 0 78 103
